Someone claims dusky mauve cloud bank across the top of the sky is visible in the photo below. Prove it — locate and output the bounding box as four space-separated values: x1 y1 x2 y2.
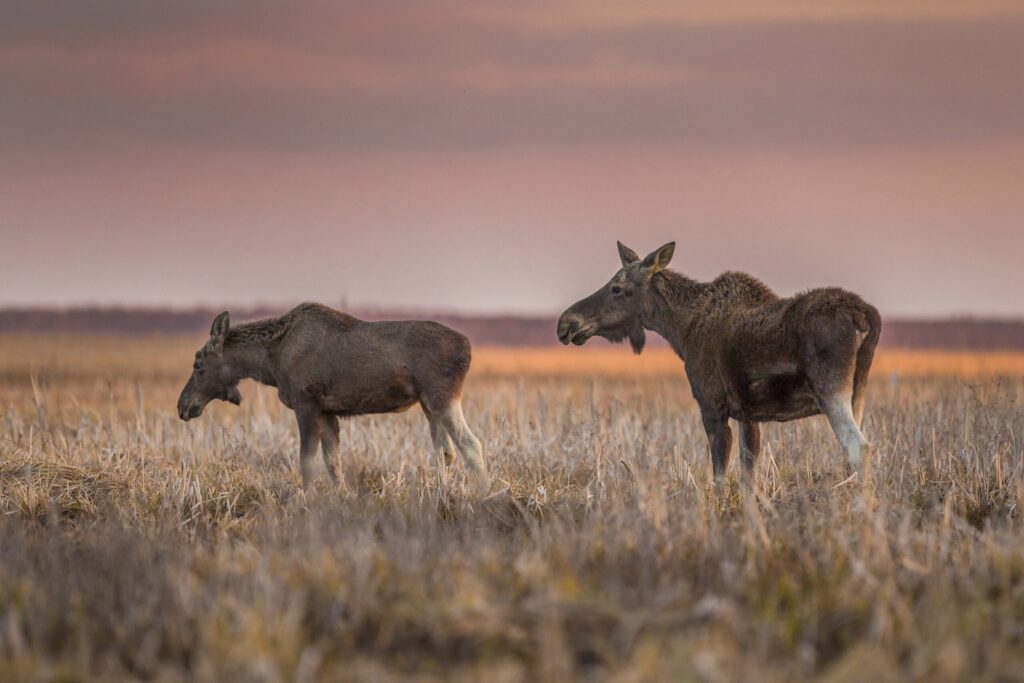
0 1 1024 154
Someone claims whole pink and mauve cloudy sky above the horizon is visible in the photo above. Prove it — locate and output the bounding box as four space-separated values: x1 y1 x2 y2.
0 0 1024 315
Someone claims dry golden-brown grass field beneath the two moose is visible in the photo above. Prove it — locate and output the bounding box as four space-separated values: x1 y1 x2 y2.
0 337 1024 683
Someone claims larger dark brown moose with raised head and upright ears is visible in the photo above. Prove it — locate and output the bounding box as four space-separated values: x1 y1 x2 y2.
558 243 882 477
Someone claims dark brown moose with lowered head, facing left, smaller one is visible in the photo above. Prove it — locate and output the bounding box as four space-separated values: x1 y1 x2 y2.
178 303 486 488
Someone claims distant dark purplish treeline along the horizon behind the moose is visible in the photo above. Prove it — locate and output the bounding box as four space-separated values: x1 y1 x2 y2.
0 307 1024 350
